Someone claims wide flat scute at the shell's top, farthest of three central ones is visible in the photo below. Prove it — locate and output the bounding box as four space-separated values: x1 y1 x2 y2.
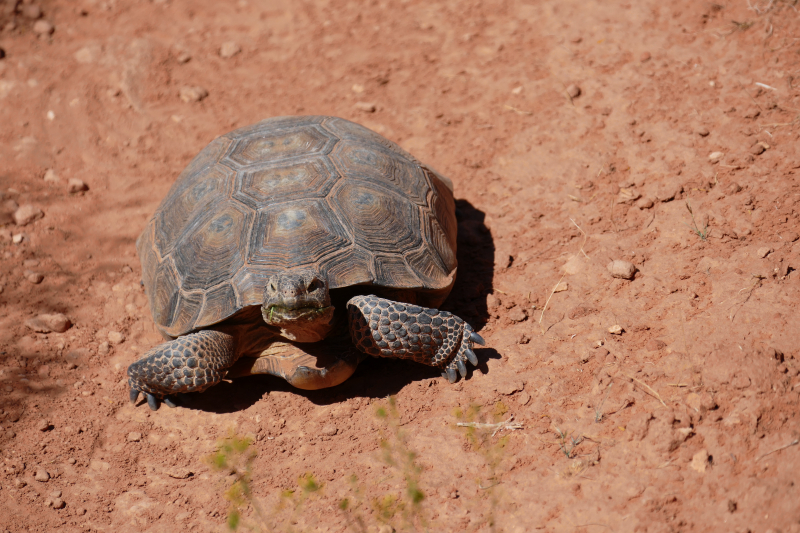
226 125 338 166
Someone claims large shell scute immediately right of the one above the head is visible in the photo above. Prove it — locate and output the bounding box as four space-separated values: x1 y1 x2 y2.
331 180 422 254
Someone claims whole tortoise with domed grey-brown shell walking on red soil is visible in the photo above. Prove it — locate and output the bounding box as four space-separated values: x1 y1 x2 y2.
128 116 484 410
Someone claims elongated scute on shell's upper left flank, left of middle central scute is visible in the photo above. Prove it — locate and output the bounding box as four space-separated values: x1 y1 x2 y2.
154 165 234 256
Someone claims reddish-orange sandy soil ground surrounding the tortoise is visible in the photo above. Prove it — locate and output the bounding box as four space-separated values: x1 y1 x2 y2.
0 0 800 532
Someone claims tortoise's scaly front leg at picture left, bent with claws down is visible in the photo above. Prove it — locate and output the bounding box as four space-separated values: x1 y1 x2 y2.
128 330 236 411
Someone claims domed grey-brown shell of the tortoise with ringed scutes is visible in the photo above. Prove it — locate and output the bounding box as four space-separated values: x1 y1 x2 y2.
136 116 456 337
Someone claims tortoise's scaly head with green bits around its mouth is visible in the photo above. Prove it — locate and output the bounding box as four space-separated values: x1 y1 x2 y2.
261 269 334 342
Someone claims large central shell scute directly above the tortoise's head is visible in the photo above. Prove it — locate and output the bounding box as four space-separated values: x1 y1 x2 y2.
247 199 351 269
